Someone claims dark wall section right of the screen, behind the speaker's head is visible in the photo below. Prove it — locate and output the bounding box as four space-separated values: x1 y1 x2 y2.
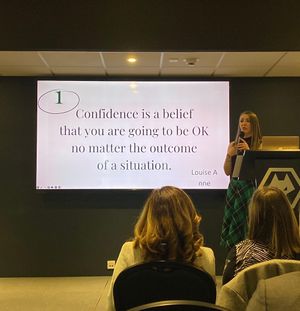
230 78 300 137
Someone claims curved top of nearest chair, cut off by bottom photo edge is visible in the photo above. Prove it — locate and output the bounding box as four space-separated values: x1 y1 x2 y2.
128 300 229 311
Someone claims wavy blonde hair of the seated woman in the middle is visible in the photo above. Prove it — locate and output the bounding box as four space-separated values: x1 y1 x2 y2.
134 186 203 262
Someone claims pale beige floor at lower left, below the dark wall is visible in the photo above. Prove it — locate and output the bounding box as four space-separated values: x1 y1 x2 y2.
0 276 221 311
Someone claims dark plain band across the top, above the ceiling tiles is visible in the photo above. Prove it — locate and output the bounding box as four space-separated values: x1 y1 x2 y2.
0 0 300 51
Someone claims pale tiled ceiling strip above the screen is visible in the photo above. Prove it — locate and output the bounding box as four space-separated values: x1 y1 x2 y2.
0 51 300 77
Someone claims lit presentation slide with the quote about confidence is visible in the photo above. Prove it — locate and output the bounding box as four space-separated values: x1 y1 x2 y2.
36 80 229 190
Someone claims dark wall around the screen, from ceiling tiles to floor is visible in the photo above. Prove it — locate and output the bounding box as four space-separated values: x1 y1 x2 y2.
0 78 300 276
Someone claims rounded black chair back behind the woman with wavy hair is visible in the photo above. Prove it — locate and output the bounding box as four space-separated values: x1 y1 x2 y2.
113 261 216 311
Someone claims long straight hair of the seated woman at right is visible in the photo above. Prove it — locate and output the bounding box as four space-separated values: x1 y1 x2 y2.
249 187 300 258
